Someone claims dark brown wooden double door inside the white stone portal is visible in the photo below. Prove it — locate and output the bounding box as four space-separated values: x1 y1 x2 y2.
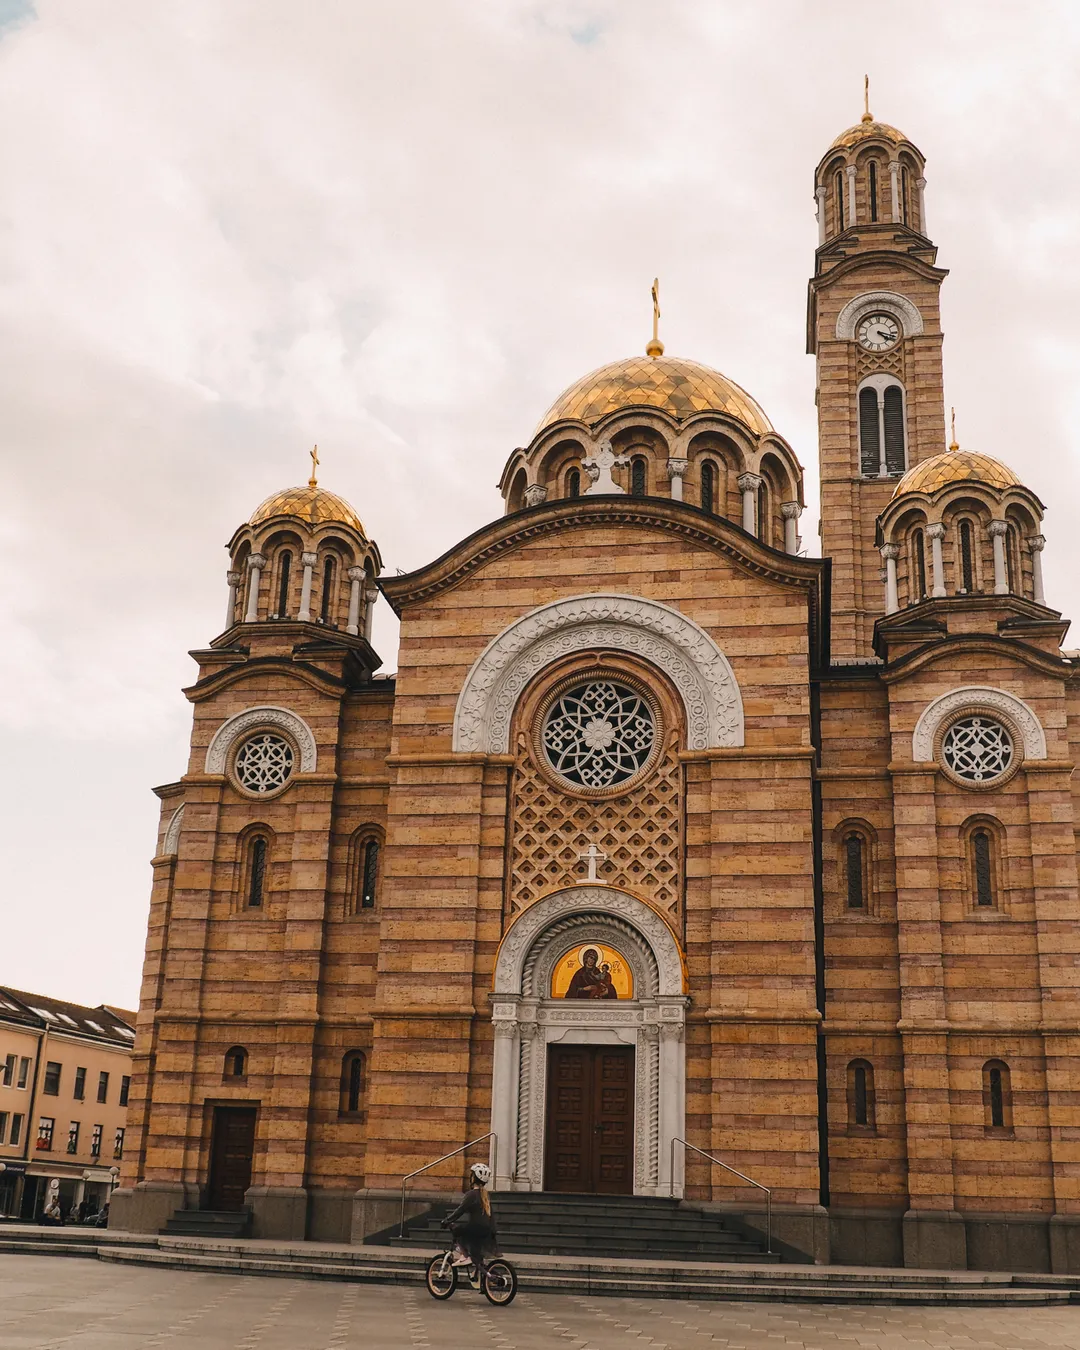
544 1045 633 1195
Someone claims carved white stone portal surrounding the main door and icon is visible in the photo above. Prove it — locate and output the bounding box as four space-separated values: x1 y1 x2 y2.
491 884 690 1196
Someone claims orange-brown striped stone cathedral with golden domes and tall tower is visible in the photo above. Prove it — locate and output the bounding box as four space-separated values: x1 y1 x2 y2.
113 112 1080 1272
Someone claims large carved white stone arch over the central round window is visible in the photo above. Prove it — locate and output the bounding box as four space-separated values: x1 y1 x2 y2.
454 593 744 755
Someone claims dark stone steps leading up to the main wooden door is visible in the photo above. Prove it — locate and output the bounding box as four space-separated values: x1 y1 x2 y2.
380 1191 780 1265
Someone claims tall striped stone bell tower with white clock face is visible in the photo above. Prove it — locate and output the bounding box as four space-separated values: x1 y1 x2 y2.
806 101 948 660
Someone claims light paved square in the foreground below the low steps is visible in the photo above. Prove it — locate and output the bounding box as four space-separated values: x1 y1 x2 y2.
0 1256 1080 1350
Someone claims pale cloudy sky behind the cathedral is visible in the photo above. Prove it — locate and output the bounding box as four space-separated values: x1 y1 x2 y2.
0 0 1080 1006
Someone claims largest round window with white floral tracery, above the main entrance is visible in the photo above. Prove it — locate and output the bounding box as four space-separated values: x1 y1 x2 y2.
541 679 656 788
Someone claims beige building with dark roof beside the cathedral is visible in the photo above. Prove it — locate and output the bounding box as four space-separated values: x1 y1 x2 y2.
0 988 135 1219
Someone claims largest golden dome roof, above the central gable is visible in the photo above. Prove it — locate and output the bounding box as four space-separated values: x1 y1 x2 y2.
536 356 772 436
